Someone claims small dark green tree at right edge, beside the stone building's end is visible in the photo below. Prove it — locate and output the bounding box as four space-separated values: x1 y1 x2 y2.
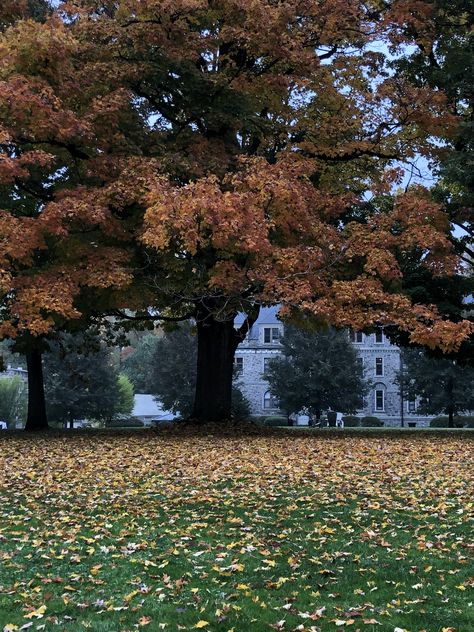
398 349 474 428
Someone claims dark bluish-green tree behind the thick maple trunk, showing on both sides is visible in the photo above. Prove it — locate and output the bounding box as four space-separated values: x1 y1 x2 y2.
149 323 250 419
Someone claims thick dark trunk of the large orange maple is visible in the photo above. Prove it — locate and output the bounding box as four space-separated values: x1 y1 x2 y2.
191 307 239 423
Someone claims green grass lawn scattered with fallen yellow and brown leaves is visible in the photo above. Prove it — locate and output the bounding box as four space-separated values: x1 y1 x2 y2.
0 430 474 632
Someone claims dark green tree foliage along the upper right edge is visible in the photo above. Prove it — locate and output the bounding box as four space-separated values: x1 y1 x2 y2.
388 0 474 366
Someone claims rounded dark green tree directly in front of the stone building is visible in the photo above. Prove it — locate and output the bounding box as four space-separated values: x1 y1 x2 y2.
265 327 368 420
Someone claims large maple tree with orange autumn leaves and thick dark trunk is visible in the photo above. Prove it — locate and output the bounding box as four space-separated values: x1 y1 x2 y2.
0 0 472 420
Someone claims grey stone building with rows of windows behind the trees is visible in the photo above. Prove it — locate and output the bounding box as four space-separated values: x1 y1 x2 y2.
235 307 431 426
